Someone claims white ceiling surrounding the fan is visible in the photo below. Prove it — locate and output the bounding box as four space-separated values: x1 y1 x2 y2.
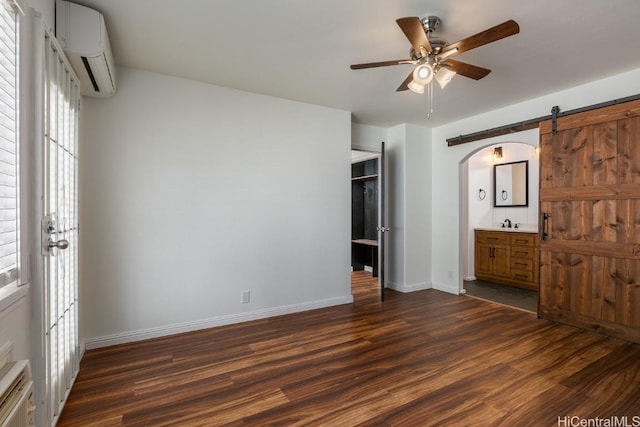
75 0 640 127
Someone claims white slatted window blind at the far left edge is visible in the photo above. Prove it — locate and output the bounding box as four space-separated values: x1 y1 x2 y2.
0 0 19 287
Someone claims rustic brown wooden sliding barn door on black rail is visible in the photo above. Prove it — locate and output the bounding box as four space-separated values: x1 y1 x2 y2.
539 101 640 342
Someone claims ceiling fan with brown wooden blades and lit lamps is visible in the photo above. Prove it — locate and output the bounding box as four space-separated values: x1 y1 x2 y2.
351 16 520 96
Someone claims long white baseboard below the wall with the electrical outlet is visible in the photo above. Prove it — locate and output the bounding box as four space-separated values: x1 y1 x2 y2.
84 295 353 350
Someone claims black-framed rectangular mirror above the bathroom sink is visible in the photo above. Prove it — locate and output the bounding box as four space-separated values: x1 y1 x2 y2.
493 160 529 208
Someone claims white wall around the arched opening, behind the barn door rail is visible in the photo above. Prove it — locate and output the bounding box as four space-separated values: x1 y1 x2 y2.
431 69 640 292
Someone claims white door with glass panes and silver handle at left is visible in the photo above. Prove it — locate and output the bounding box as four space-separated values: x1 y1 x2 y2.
36 12 80 425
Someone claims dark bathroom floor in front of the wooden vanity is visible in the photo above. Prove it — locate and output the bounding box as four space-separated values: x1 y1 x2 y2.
464 280 538 313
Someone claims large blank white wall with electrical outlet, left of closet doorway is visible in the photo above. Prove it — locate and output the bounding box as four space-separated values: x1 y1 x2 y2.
80 69 352 347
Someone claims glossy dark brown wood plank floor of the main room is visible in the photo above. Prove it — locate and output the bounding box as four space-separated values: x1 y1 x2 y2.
58 273 640 427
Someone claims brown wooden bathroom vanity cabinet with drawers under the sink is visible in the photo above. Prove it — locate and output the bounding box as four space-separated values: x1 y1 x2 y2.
475 230 539 290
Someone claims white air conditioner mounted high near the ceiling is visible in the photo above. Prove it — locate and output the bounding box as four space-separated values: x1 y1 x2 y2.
56 0 116 97
